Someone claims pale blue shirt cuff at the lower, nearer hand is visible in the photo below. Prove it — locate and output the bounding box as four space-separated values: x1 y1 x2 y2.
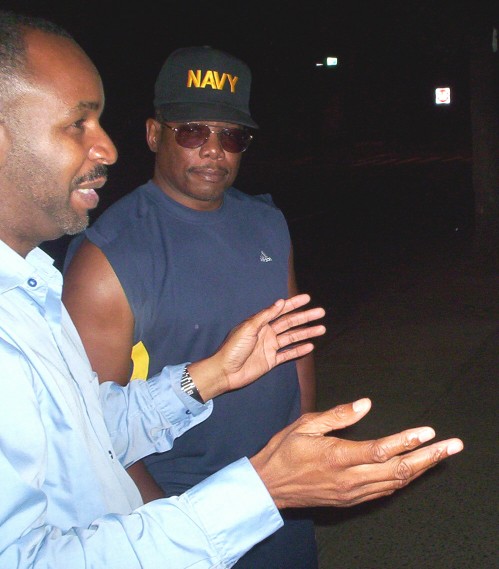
183 457 283 566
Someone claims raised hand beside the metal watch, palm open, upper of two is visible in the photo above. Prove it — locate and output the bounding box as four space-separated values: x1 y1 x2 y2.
189 294 326 401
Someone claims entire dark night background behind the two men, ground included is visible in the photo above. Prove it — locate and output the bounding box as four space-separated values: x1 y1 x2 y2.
4 0 499 569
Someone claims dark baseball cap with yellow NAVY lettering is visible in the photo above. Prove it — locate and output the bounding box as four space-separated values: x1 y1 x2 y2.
154 46 258 128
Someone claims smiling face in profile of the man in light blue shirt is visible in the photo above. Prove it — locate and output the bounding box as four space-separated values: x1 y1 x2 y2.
0 31 117 254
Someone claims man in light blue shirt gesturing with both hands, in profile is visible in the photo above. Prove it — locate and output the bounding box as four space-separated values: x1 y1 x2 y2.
0 11 463 569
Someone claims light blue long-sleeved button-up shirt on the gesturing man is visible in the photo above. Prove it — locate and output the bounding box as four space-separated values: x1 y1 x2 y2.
0 241 282 569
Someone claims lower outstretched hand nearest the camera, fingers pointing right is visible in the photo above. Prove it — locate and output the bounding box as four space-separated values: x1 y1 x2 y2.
251 399 463 508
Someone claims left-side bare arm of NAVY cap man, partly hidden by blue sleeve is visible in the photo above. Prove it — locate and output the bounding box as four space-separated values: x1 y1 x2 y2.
62 239 164 502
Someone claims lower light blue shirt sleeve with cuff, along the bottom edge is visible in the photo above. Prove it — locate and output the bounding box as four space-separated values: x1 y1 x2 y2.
0 459 282 569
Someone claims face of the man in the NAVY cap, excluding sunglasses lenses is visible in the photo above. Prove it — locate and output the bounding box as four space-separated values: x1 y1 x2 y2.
147 119 245 211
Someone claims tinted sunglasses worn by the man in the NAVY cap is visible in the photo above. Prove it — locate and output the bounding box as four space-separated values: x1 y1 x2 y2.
161 122 253 154
